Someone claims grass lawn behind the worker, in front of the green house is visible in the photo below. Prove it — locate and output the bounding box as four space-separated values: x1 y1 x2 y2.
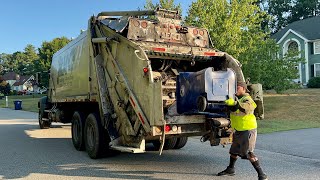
258 89 320 133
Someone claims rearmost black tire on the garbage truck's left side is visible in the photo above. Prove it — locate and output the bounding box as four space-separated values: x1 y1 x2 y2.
84 113 110 159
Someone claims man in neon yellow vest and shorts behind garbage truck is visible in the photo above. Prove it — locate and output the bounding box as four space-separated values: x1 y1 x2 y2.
217 82 268 180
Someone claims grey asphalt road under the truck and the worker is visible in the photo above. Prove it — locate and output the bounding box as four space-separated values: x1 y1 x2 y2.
0 108 320 180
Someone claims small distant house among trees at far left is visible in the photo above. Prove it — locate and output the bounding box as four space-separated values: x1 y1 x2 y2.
2 72 34 91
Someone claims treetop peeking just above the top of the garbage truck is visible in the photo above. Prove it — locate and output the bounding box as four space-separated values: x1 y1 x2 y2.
144 0 182 13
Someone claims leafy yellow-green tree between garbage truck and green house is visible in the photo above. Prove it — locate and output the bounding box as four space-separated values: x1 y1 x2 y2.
186 0 301 92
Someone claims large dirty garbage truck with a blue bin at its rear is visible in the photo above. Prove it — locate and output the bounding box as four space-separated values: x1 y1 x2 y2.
38 8 263 159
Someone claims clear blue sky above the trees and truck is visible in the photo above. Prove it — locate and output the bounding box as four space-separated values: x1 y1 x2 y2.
0 0 194 54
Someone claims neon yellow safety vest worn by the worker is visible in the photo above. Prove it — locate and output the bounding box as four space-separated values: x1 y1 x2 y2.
230 93 257 131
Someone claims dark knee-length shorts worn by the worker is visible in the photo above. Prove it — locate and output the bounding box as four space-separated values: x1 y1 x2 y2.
230 129 257 158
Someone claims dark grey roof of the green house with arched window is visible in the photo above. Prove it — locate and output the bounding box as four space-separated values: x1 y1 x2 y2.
272 16 320 42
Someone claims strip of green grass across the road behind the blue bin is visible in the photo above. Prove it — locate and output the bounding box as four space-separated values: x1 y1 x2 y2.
0 94 45 112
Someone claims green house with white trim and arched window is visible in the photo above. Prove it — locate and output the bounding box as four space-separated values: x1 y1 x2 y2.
272 16 320 85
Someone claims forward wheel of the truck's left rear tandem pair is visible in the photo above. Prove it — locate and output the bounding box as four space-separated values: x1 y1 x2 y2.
71 111 85 151
